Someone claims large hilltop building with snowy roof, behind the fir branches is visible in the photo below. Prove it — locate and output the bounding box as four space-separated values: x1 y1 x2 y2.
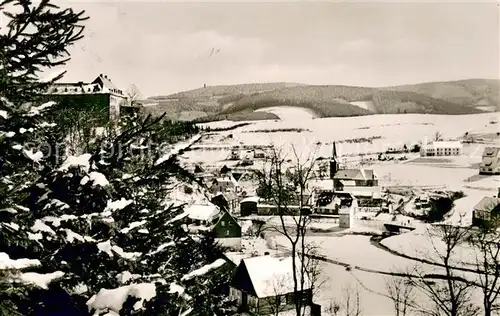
46 74 137 121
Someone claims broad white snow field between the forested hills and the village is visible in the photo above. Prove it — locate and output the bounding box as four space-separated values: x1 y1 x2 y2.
199 108 498 156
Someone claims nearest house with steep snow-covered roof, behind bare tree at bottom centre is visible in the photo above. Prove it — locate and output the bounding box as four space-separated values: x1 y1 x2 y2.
229 255 313 315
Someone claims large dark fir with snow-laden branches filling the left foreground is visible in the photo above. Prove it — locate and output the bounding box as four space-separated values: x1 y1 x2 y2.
0 0 231 316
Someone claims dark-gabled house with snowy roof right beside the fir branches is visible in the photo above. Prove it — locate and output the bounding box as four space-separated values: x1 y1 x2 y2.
185 203 241 250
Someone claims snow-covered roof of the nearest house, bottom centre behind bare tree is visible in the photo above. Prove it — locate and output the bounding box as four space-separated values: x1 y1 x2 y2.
242 255 311 298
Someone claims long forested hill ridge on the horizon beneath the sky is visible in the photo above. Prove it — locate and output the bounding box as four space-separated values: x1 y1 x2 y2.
146 79 500 120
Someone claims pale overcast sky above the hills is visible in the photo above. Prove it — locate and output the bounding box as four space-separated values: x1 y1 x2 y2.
53 1 500 96
